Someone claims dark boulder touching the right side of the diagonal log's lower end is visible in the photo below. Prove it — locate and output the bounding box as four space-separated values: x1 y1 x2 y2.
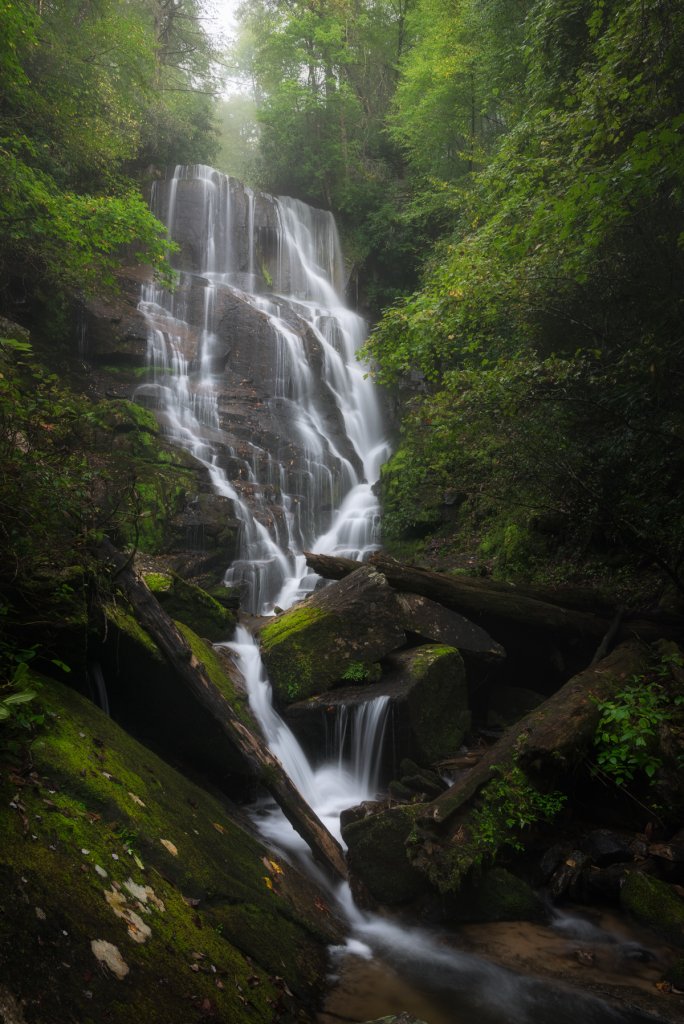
342 804 427 906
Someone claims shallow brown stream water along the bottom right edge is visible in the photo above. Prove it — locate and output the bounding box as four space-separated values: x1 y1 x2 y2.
317 910 684 1024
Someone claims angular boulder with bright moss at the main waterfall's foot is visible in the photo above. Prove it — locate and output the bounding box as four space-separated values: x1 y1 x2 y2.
260 565 405 705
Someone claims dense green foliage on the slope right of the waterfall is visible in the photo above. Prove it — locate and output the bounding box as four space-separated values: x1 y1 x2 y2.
366 0 684 589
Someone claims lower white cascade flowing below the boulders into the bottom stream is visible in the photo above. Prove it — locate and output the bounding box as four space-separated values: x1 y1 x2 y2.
222 627 652 1024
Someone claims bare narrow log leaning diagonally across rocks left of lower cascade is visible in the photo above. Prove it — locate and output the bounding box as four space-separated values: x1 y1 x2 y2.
102 544 347 879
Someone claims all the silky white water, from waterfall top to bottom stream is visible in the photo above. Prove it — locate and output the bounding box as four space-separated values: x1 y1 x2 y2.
138 165 663 1024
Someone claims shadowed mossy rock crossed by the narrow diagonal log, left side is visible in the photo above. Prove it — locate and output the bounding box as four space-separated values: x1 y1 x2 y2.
100 599 259 799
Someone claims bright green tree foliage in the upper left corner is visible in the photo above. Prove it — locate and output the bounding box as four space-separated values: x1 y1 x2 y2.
0 0 219 308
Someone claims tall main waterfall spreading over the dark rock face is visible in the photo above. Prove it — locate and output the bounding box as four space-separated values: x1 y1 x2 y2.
137 165 388 614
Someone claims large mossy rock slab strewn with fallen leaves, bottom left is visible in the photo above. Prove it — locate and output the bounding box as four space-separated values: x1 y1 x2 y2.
0 680 341 1024
